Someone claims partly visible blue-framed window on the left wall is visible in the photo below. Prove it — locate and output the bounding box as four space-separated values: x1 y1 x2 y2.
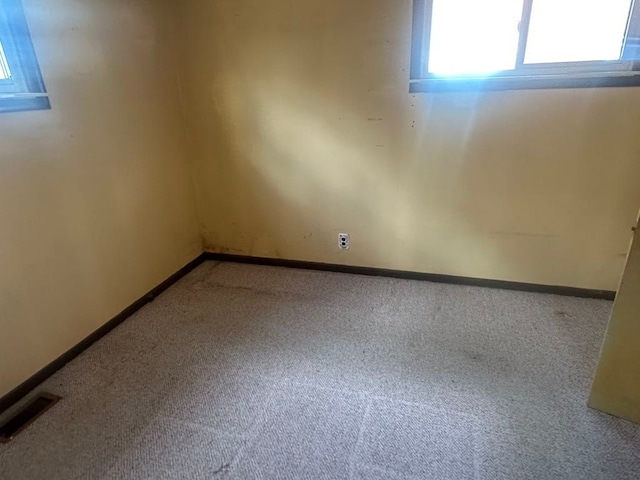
0 0 50 113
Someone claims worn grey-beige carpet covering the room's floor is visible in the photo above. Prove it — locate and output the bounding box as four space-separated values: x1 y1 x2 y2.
0 262 640 480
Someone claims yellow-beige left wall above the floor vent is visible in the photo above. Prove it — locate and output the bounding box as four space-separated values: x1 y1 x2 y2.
0 0 202 396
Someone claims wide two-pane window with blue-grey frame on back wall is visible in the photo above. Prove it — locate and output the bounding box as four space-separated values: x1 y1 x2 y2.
410 0 640 92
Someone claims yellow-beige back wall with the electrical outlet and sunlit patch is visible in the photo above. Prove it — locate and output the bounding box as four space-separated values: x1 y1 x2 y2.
180 0 640 290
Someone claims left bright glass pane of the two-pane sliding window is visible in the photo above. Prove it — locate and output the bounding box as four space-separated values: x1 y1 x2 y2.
429 0 522 75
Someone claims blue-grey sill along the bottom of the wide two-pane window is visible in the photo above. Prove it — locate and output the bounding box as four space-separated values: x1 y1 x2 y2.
409 72 640 93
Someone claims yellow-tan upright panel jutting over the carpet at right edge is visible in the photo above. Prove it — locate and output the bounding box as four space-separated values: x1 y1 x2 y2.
589 217 640 423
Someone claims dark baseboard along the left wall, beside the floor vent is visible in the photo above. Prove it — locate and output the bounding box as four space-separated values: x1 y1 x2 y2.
0 254 207 414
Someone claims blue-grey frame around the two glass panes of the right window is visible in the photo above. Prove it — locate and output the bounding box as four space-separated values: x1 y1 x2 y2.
409 0 640 93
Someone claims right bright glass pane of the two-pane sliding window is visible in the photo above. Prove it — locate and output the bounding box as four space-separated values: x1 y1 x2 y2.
524 0 632 63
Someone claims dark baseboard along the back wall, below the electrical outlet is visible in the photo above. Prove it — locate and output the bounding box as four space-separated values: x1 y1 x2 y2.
203 252 616 300
